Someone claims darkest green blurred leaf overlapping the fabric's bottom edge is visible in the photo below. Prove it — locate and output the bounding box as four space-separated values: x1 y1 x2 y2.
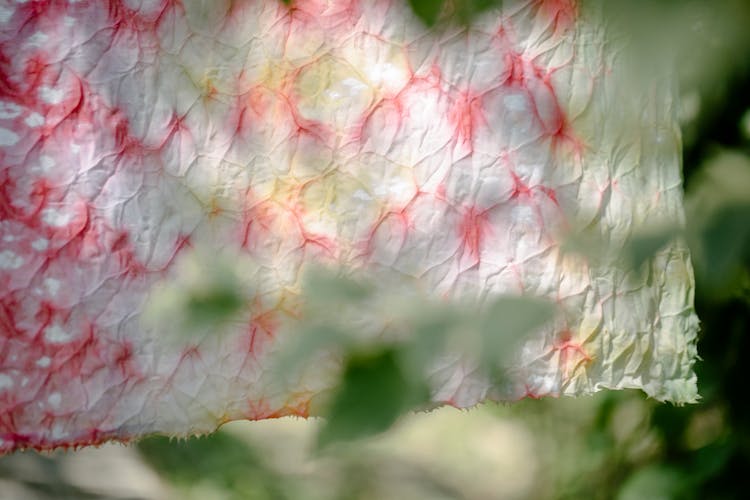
318 348 429 448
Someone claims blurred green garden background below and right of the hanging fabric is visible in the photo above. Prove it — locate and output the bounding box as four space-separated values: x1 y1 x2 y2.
0 0 750 500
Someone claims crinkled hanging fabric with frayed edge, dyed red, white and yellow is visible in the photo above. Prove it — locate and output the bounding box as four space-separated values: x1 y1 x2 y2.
0 0 697 452
